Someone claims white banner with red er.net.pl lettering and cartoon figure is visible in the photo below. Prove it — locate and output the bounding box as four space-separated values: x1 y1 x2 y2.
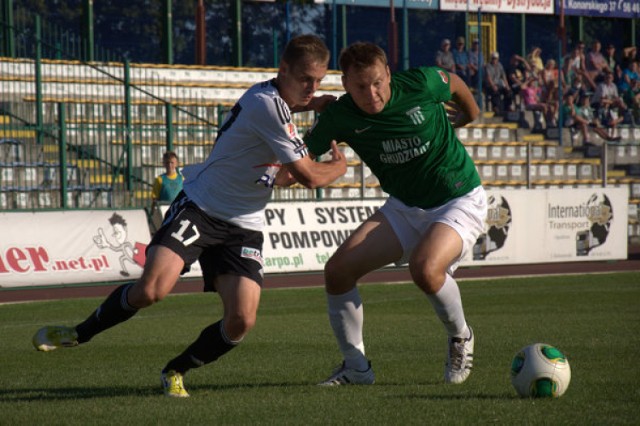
0 210 150 288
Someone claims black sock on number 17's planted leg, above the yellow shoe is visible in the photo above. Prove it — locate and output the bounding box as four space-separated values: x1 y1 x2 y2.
162 320 239 374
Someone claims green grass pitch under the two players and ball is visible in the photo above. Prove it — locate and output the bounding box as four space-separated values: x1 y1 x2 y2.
0 272 640 425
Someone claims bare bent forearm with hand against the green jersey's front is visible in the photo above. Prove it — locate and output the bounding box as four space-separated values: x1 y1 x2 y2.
284 141 347 189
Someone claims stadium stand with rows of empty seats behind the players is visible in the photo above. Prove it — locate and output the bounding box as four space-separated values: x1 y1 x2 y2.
0 54 640 243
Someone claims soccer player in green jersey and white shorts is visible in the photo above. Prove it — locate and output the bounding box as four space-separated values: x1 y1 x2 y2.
305 42 487 386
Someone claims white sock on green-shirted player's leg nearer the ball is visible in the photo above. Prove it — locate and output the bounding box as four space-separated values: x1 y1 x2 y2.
427 274 469 338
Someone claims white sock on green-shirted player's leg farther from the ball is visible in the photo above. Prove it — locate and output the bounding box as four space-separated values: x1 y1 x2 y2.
327 287 369 371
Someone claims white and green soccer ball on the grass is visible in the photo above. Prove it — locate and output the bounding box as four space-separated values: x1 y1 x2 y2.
511 343 571 398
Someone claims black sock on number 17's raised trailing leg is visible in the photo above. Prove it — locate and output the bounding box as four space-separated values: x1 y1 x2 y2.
76 283 138 343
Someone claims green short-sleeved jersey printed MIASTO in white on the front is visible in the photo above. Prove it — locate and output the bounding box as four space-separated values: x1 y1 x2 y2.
304 67 481 208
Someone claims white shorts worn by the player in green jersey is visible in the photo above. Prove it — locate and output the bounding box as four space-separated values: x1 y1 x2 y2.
380 186 487 274
